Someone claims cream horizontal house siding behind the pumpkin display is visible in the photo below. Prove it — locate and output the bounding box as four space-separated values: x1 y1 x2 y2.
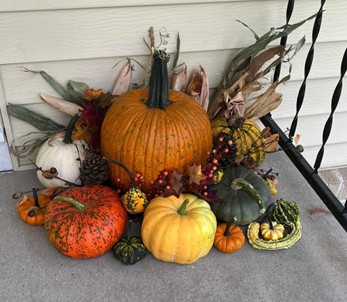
0 0 347 170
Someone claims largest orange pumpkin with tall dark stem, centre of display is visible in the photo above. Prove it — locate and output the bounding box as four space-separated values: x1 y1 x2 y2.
101 51 212 191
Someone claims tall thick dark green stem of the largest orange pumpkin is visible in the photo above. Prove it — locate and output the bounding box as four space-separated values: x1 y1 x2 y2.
145 49 172 110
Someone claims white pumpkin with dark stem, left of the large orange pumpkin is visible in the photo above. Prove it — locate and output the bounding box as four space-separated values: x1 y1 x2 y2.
35 132 87 188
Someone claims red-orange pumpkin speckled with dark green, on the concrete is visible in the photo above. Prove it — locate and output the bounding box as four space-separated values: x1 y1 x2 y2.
45 185 127 258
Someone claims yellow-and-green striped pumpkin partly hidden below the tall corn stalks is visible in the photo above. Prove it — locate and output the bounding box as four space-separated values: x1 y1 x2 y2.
211 117 265 166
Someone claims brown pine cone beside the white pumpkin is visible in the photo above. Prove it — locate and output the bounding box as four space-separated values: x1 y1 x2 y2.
81 152 108 185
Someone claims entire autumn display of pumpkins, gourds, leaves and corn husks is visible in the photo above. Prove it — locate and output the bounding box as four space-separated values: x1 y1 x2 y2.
8 20 314 264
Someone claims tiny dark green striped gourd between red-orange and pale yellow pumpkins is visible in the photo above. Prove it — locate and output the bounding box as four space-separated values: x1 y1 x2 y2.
113 236 147 264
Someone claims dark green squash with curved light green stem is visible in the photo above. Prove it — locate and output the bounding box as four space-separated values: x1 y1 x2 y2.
209 166 271 225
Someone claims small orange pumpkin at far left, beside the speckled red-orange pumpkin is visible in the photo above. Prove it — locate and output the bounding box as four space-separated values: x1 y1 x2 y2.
17 189 51 226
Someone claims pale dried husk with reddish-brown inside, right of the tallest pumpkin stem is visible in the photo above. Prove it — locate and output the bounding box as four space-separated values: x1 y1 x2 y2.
186 66 209 111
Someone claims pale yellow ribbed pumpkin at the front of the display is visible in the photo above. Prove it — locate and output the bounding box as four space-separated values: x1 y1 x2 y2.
141 194 217 264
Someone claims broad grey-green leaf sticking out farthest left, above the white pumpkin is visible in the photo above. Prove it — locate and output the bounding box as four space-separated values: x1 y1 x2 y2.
7 103 66 131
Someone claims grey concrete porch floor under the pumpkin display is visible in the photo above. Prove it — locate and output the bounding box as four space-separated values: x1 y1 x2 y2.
0 153 347 302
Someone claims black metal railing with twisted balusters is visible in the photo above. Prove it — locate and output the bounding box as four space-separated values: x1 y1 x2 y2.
261 0 347 232
